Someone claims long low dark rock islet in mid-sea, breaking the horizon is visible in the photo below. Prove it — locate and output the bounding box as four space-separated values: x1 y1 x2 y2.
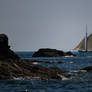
32 48 76 57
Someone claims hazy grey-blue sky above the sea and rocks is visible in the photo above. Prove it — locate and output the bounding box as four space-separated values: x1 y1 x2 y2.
0 0 92 51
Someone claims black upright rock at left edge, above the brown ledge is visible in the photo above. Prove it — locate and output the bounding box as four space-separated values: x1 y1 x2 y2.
0 34 19 59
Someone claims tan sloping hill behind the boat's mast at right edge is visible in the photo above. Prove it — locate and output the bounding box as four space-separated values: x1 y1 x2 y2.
74 34 92 51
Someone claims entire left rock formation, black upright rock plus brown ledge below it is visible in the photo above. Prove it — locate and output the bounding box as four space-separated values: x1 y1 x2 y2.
0 34 71 80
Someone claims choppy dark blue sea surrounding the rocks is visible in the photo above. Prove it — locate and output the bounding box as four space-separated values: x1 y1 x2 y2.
0 51 92 92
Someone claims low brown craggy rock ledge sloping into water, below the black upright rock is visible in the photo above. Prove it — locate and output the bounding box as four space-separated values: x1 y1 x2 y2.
0 59 71 80
